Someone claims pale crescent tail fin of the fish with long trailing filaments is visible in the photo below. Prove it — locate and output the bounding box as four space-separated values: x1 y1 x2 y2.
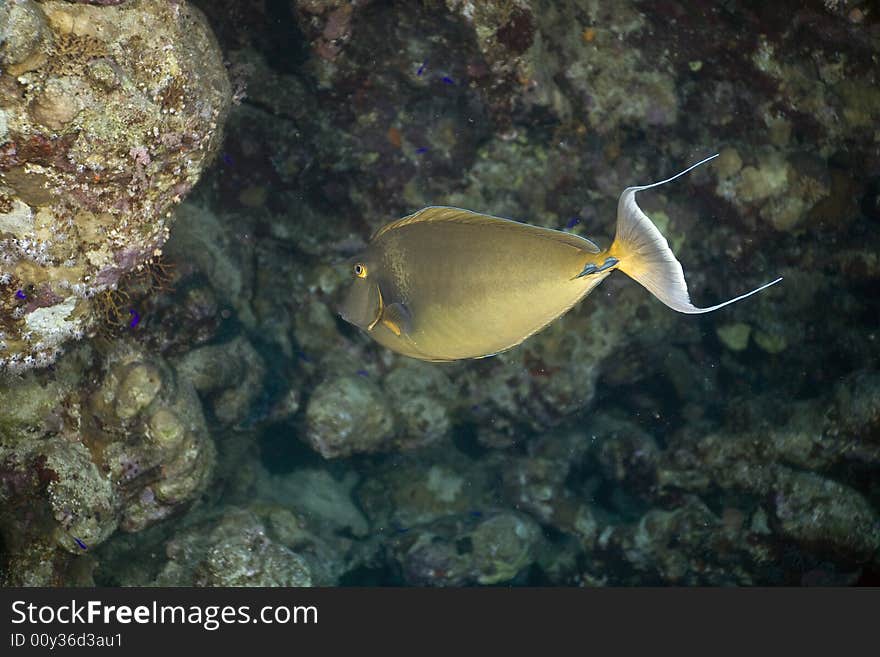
609 154 782 314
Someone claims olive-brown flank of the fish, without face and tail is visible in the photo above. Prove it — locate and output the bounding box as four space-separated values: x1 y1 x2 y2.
369 207 599 360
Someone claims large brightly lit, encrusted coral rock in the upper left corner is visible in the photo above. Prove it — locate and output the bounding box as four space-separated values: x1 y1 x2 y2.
0 0 231 372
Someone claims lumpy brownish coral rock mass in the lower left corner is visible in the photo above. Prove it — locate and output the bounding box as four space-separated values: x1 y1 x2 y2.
0 342 214 584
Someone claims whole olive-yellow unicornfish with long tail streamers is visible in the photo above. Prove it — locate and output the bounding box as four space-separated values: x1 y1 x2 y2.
339 154 782 361
